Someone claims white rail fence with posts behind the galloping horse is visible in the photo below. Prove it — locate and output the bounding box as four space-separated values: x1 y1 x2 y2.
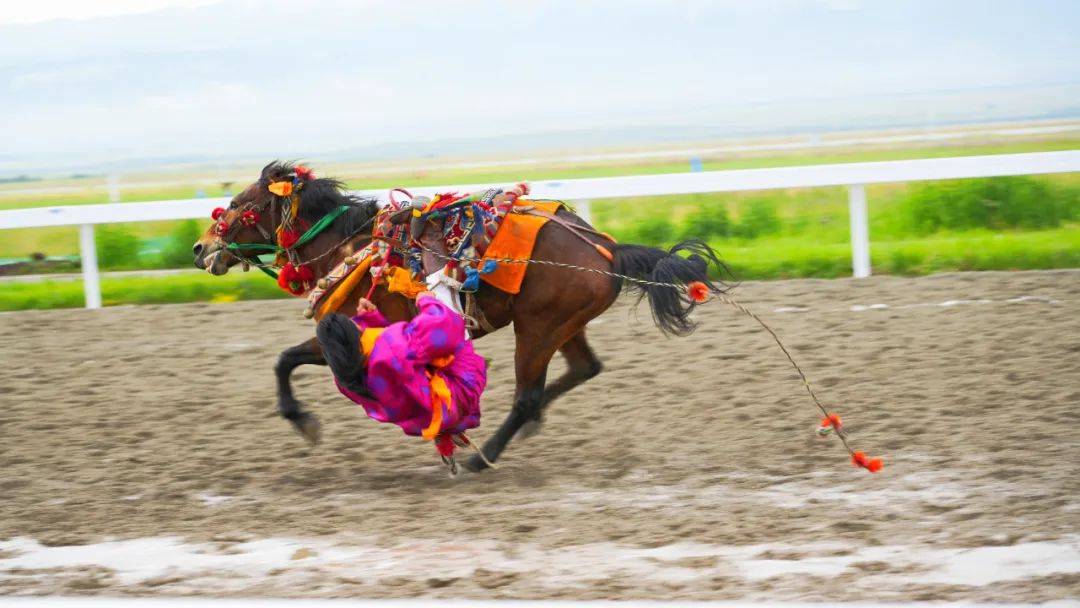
0 150 1080 308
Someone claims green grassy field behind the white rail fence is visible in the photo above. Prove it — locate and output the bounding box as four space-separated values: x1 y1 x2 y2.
0 126 1080 310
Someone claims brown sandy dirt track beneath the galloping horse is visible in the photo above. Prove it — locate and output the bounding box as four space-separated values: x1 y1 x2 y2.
0 271 1080 602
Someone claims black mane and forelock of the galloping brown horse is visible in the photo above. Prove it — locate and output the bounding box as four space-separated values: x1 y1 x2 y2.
259 161 379 234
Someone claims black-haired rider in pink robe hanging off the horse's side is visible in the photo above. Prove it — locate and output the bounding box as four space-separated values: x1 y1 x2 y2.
315 292 487 472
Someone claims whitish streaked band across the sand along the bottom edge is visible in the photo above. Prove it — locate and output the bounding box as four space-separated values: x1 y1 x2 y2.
0 535 1080 592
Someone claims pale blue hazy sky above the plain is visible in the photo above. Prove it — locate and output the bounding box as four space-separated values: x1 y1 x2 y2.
0 0 1080 174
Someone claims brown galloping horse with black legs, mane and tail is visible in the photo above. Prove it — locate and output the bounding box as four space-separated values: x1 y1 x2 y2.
194 162 723 471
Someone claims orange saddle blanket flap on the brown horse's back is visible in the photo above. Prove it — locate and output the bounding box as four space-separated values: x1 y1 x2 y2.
481 199 563 294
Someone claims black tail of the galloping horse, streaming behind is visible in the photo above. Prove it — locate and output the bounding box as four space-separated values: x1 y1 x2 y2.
611 239 730 336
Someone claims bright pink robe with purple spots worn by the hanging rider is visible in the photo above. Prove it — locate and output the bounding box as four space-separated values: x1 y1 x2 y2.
335 295 487 435
